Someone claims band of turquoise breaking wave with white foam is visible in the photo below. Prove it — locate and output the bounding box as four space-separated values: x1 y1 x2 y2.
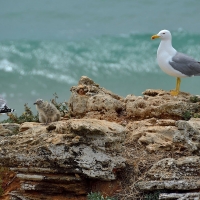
0 32 200 84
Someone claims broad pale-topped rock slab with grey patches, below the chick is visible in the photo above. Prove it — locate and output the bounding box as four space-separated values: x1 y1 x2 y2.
0 119 125 180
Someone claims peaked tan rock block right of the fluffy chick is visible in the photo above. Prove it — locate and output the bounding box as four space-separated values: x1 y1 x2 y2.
69 76 125 121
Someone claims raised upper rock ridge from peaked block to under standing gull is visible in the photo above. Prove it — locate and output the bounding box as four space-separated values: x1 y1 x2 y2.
69 76 200 122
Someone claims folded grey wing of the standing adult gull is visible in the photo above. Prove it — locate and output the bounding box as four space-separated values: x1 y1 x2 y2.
169 52 200 76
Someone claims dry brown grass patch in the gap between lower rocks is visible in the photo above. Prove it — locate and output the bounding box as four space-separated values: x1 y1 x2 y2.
117 142 174 200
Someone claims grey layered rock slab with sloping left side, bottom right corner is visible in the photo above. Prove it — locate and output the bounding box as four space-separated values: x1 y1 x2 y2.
138 156 200 191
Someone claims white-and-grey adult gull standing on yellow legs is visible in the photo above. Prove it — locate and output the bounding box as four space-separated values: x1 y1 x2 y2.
151 30 200 96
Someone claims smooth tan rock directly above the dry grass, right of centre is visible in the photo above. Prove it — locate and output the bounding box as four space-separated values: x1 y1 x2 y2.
126 118 177 152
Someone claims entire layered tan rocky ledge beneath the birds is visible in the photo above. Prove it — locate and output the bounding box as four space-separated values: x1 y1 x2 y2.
0 76 200 200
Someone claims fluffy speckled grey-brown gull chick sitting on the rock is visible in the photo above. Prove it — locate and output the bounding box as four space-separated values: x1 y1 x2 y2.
34 99 60 124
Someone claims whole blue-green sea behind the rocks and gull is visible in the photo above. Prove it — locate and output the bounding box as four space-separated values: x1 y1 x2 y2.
0 0 200 120
